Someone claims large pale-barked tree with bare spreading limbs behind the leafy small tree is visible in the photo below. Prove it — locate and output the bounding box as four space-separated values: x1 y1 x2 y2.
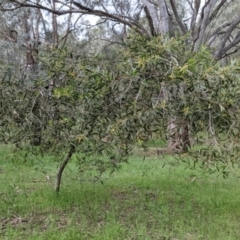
2 0 240 149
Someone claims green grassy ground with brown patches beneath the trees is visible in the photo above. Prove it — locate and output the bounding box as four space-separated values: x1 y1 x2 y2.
0 145 240 240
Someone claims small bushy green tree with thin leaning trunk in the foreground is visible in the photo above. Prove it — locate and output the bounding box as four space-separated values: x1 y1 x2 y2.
0 31 240 190
